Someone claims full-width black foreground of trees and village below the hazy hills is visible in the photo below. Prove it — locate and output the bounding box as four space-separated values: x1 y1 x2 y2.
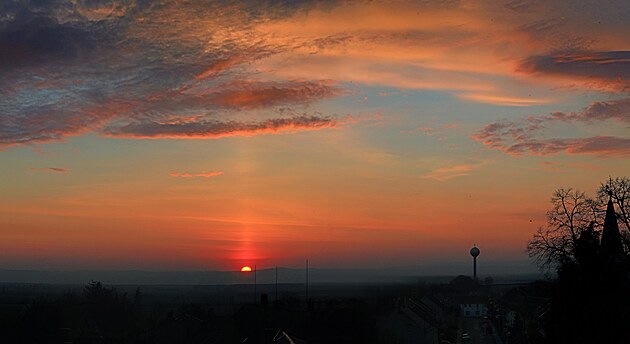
0 272 630 344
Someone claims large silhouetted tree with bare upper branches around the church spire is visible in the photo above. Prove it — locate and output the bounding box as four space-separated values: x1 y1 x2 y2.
527 177 630 343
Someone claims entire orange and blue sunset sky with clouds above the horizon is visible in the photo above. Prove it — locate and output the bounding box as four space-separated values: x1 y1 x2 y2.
0 0 630 270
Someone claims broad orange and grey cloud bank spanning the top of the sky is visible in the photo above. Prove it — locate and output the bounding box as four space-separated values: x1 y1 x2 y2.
0 0 630 150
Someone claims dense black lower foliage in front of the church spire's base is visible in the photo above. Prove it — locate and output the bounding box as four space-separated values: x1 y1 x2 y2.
547 222 630 343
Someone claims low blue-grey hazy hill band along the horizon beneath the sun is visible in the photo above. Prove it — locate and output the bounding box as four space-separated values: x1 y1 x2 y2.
0 262 541 285
